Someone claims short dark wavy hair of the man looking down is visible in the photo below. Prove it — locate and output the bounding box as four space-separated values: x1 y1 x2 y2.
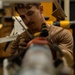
14 2 41 12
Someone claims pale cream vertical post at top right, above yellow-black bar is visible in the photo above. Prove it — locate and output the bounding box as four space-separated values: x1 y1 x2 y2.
64 0 70 20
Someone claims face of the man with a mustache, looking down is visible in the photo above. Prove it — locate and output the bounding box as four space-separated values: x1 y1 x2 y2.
18 6 43 30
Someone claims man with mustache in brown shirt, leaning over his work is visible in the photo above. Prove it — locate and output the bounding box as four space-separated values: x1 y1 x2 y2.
11 3 73 65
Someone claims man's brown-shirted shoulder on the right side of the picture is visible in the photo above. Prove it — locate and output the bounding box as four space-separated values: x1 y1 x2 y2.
49 25 73 49
